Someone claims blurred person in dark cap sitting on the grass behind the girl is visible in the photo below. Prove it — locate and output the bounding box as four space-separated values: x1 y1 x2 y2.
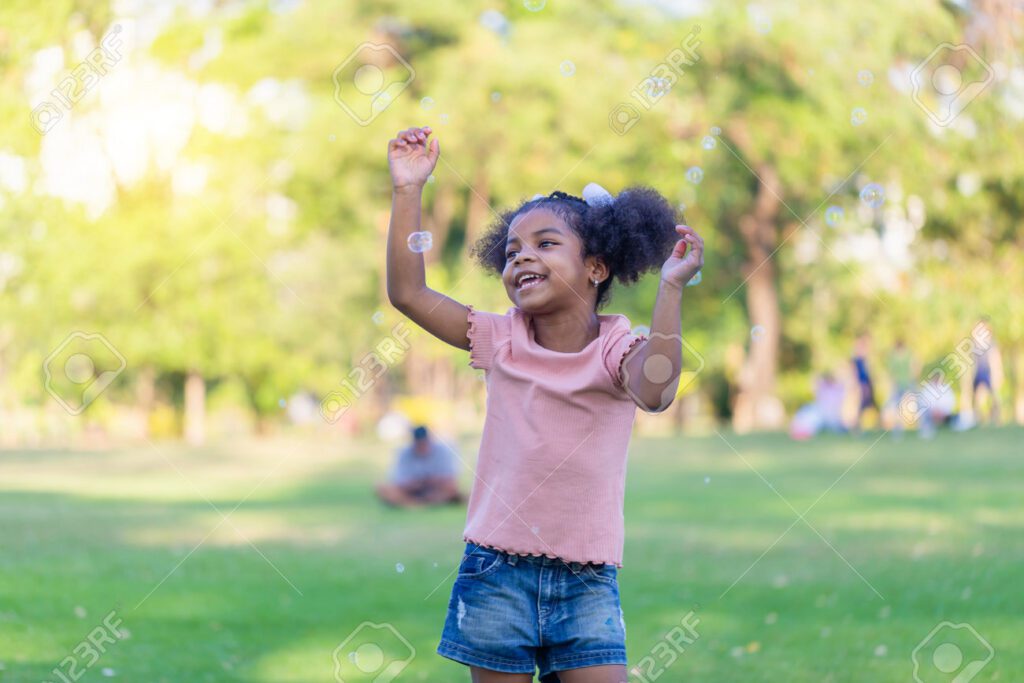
377 425 465 508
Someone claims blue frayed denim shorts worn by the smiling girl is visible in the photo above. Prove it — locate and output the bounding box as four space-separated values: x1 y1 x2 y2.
437 543 626 683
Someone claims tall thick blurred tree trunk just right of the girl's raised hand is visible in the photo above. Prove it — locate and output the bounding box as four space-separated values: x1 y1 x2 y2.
732 164 785 432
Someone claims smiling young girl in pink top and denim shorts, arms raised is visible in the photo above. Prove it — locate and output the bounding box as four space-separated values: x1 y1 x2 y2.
387 128 703 683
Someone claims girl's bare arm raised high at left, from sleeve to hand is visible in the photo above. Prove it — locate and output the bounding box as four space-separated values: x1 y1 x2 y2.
387 127 469 350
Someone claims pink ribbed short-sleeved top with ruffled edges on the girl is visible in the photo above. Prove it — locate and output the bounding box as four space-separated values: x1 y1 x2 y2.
463 306 644 567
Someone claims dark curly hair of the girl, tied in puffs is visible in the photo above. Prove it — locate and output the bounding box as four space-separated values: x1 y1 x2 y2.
470 186 679 309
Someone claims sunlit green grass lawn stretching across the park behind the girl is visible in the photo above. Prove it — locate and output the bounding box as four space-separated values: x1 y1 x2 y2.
0 428 1024 683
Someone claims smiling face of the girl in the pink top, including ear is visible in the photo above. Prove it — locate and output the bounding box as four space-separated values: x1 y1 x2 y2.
502 208 605 312
